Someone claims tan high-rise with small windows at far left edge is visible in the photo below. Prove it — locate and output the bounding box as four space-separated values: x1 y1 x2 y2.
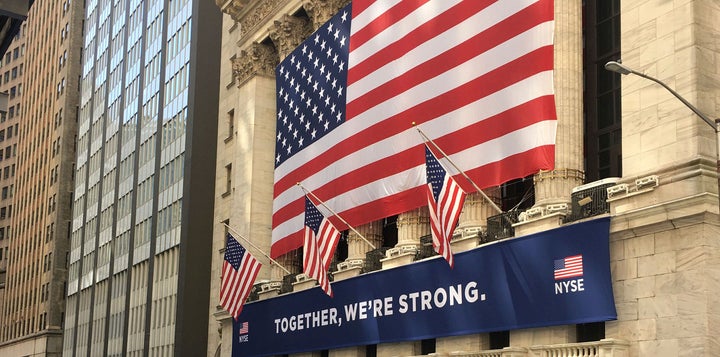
0 0 83 356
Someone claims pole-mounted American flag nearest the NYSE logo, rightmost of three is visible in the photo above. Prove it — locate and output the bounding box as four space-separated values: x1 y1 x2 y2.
425 147 465 268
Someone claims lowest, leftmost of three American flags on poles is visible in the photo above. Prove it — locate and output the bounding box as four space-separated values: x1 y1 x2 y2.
220 233 262 319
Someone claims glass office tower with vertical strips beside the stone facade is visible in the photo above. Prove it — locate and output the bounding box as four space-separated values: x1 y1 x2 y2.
63 0 220 356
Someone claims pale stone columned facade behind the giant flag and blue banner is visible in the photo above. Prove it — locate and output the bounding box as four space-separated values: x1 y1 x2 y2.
208 0 720 356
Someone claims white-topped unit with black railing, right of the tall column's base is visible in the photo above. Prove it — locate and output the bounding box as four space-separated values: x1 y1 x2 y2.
565 177 627 222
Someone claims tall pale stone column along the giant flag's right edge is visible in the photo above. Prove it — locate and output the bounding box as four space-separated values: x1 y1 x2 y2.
515 0 585 236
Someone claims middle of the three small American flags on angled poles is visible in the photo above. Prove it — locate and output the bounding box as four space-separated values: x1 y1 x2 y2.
303 197 340 296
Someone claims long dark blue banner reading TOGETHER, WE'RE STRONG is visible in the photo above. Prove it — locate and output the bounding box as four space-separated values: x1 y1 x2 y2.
232 218 617 357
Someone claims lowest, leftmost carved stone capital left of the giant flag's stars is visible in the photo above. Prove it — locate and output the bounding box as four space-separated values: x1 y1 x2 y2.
232 42 278 88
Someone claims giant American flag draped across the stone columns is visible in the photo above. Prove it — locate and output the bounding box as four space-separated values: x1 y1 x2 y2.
272 0 556 256
